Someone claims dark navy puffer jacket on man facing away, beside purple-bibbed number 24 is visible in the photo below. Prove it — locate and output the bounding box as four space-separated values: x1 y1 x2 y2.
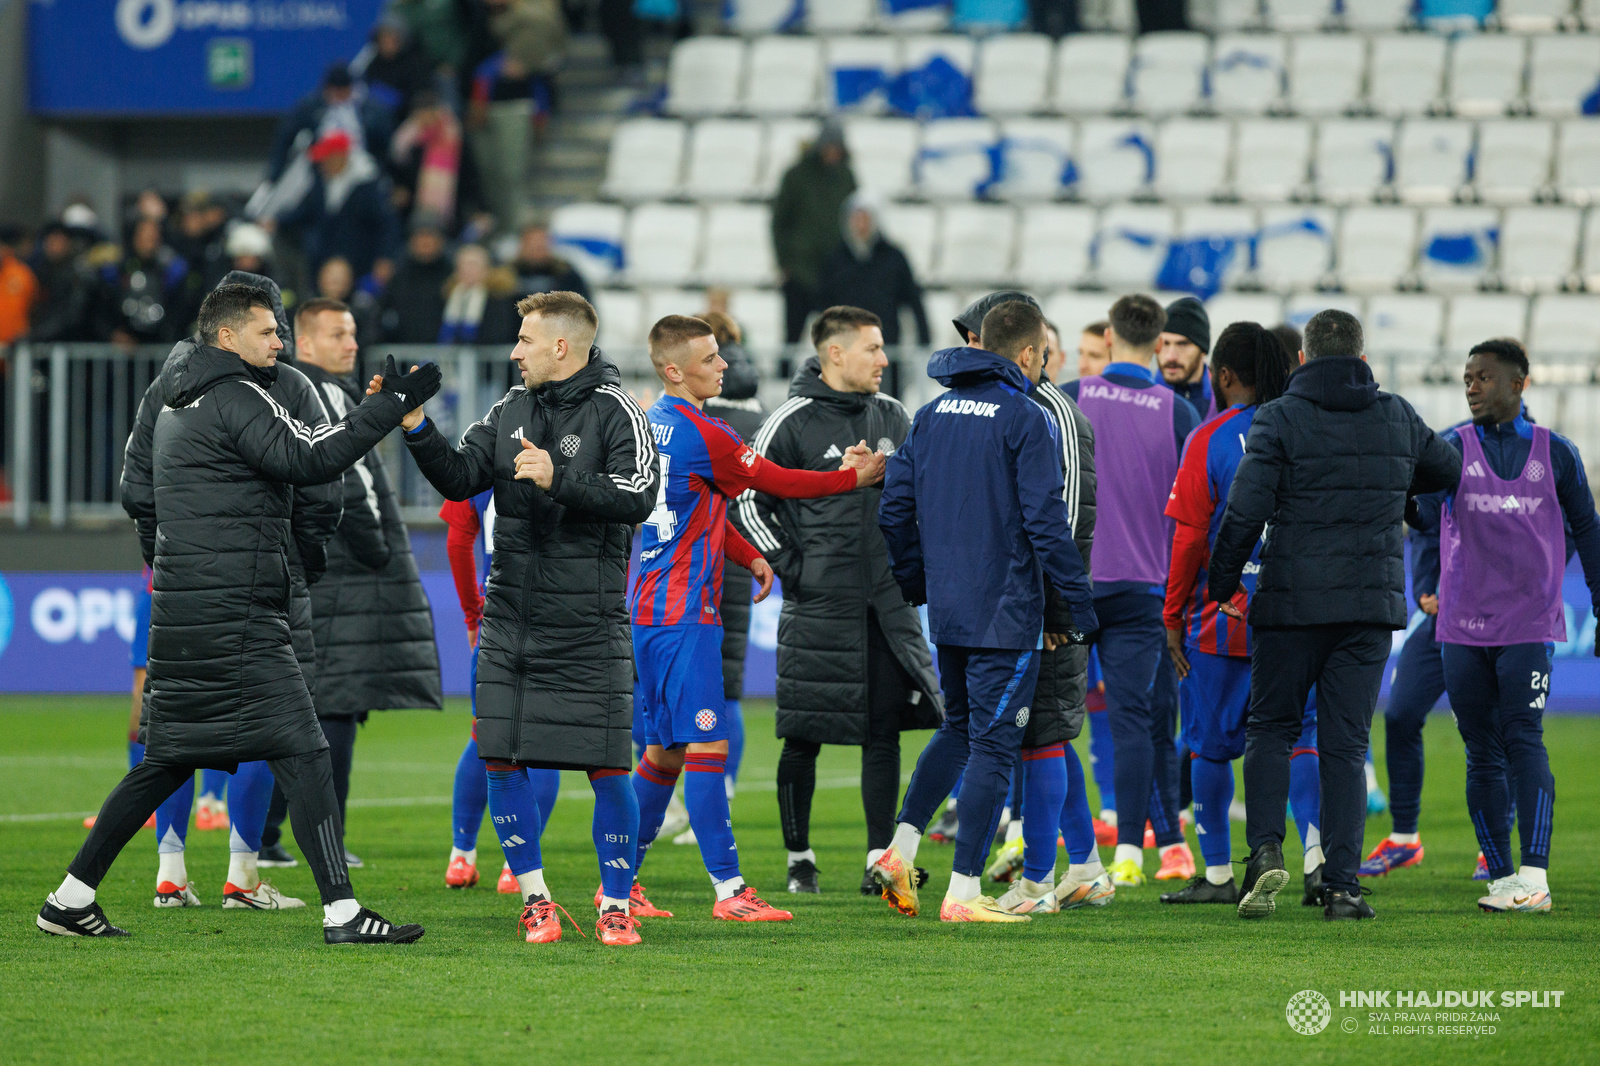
1208 357 1461 629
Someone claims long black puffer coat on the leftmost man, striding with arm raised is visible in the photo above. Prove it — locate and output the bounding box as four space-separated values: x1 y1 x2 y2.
144 347 405 758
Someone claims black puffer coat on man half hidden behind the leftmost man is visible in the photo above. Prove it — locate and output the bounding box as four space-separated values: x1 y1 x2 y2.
301 363 443 719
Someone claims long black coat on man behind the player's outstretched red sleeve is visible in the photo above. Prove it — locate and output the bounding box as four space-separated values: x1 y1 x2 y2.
734 357 944 744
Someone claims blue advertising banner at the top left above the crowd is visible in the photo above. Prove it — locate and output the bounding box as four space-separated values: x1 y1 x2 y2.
27 0 384 115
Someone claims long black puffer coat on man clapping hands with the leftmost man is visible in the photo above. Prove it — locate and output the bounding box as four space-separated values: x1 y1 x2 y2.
406 347 661 770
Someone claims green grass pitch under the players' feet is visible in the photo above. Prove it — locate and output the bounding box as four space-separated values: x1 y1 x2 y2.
0 698 1600 1066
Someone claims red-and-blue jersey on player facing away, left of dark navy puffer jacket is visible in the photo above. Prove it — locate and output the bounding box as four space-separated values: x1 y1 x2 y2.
1166 403 1261 658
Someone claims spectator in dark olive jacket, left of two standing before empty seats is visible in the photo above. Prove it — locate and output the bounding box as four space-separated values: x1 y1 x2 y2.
773 120 857 344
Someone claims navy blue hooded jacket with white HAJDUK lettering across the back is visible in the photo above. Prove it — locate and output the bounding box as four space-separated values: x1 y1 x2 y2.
878 347 1099 648
